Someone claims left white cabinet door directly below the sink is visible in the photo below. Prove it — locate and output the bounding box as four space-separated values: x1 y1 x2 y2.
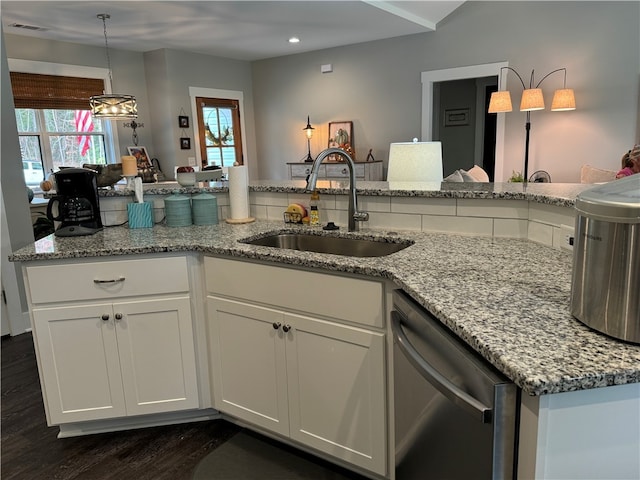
207 296 289 435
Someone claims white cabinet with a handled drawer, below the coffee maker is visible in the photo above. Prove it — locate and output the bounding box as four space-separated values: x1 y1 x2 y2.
26 257 199 425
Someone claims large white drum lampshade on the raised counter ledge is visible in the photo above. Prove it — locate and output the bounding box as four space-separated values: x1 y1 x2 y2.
387 142 443 182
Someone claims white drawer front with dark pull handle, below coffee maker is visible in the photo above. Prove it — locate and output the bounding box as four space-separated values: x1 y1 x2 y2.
26 257 189 304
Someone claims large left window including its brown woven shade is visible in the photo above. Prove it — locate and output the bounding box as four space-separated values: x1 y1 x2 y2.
10 72 113 191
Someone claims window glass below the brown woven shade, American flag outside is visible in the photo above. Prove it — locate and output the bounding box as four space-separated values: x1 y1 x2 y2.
16 108 107 188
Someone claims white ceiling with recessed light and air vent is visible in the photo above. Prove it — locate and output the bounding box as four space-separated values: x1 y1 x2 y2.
0 0 464 61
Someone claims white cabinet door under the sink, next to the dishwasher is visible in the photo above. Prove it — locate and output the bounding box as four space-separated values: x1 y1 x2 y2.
284 314 387 475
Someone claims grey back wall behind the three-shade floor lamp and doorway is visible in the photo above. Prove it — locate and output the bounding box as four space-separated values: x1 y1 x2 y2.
253 1 640 182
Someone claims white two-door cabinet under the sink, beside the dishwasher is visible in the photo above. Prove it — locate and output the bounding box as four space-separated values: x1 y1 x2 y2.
205 258 387 475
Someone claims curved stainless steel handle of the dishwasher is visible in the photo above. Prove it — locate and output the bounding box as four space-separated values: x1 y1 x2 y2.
391 311 493 423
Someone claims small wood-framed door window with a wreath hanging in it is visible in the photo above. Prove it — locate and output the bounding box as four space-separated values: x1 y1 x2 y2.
196 97 244 167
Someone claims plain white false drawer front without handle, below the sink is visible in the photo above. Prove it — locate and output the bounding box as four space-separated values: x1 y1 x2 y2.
204 257 384 327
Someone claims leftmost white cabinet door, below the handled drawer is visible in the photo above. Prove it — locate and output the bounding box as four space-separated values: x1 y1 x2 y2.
33 304 126 425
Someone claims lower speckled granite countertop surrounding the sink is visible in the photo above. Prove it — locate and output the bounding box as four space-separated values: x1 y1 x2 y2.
10 218 640 395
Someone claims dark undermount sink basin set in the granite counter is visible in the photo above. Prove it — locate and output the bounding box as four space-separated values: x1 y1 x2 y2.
240 231 413 257
